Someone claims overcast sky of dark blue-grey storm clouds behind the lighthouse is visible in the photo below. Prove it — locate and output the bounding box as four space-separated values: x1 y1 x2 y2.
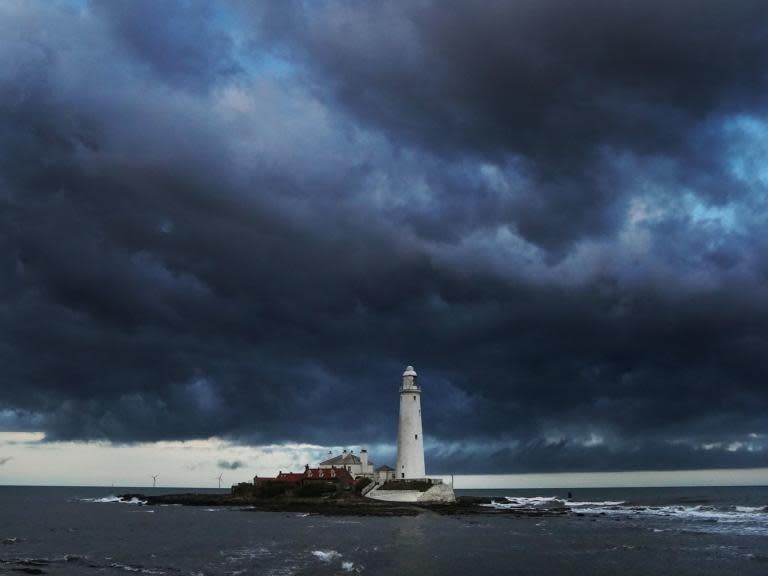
0 0 768 482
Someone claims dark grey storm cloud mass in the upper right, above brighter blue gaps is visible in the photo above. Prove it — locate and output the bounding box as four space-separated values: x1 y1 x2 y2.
258 0 768 250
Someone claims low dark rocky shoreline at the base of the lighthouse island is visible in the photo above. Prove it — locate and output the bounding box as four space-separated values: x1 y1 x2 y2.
119 493 569 517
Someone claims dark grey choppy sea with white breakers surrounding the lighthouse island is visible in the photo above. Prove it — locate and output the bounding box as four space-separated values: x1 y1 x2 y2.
0 486 768 576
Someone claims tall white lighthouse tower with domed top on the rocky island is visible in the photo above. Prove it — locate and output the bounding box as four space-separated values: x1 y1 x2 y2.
395 366 426 479
